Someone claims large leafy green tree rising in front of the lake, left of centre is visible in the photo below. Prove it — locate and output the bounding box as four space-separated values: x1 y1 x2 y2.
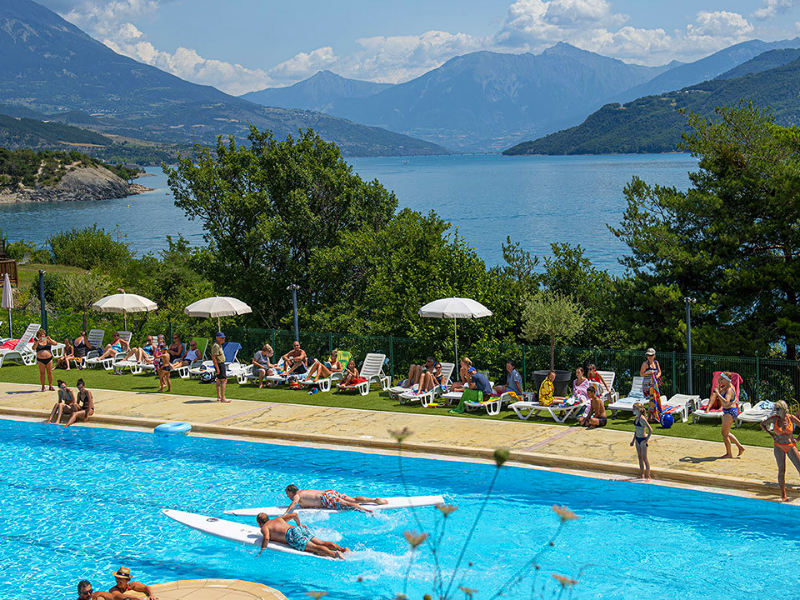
164 128 397 324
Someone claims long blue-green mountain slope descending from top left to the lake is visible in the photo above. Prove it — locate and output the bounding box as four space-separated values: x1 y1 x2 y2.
0 0 446 156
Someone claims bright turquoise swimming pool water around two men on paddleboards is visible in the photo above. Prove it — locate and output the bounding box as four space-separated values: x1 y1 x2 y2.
0 420 800 600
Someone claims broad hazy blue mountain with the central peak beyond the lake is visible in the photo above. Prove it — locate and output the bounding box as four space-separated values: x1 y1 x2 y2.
322 43 665 152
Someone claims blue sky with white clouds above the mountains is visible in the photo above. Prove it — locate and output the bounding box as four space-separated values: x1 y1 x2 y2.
40 0 800 94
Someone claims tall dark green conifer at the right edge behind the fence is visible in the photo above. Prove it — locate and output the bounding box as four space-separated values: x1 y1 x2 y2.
612 103 800 359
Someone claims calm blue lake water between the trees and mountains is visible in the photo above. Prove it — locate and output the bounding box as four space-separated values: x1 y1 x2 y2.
0 154 697 273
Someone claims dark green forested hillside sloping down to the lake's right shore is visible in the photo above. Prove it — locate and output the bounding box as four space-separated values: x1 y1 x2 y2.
504 59 800 156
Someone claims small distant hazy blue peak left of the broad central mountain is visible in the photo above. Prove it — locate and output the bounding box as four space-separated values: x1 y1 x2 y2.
244 71 392 112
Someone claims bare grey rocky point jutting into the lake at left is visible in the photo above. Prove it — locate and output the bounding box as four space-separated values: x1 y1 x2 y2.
0 167 150 204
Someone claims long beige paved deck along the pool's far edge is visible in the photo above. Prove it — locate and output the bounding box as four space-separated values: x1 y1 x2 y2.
0 383 800 504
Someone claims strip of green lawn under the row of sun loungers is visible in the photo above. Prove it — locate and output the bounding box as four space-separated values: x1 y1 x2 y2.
0 363 772 452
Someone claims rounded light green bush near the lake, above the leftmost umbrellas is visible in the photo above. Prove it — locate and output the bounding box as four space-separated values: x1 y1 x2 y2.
47 224 132 270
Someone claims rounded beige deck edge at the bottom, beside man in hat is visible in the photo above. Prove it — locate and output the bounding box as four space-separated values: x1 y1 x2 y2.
125 579 287 600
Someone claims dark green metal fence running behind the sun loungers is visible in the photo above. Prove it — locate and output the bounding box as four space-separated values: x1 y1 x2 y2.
6 310 800 403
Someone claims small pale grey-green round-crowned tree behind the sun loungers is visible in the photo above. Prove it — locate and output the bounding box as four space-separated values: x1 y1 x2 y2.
522 290 586 369
